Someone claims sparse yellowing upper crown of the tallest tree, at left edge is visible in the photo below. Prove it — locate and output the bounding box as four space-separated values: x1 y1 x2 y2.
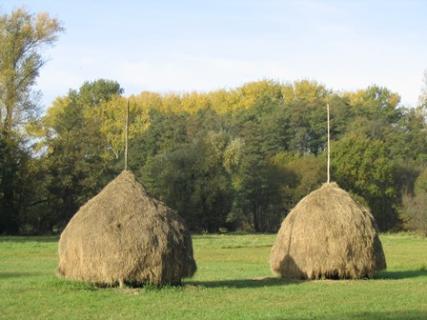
0 9 62 135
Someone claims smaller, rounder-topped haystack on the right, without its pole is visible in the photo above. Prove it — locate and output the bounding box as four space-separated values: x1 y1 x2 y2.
270 183 386 279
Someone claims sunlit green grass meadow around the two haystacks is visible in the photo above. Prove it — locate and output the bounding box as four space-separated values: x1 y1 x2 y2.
0 234 427 320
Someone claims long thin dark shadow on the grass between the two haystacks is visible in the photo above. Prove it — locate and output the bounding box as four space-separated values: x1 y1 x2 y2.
185 277 302 289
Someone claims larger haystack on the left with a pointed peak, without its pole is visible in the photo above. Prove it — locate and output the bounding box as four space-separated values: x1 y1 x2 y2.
58 170 196 285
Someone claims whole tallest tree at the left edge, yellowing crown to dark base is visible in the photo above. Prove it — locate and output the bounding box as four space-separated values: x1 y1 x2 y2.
0 9 62 233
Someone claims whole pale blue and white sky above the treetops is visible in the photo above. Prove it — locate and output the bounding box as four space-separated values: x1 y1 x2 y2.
0 0 427 106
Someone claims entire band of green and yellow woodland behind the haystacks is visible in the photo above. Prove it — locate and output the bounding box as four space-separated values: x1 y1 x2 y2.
0 9 427 234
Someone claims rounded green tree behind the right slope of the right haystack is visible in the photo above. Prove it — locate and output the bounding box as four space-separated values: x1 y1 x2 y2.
331 134 398 230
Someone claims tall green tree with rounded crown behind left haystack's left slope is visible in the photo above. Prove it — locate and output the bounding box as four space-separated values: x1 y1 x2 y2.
35 80 123 228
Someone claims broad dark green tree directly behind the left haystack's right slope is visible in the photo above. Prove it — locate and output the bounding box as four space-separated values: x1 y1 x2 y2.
142 109 232 232
